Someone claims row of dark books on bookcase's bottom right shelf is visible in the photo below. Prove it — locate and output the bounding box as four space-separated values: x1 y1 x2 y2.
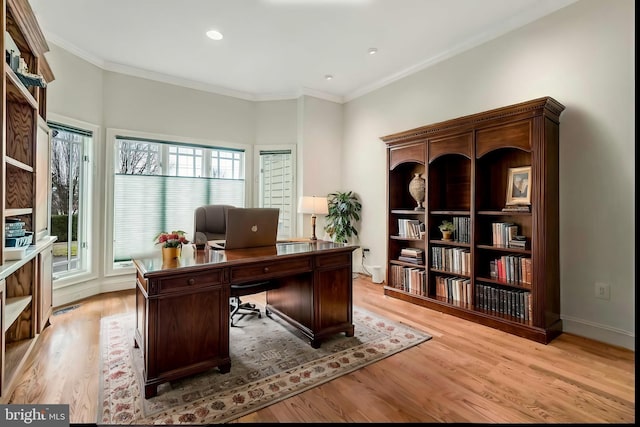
474 283 532 321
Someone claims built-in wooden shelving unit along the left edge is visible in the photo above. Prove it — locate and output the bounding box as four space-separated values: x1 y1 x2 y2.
0 0 56 403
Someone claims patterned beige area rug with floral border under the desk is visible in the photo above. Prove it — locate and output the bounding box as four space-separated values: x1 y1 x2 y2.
97 307 431 425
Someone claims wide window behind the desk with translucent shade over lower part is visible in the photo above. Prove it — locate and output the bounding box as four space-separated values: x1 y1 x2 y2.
113 136 246 265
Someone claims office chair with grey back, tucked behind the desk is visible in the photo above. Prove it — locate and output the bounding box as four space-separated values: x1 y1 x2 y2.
193 205 273 326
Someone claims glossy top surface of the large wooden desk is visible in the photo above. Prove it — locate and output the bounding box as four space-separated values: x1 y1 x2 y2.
133 240 358 276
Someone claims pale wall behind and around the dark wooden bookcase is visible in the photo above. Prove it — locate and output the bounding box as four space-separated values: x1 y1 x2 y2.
342 0 635 349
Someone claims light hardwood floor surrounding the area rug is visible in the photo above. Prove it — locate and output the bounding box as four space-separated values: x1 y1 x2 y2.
10 277 635 424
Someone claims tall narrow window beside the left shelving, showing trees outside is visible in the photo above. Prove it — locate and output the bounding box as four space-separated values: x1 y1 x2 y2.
48 122 93 280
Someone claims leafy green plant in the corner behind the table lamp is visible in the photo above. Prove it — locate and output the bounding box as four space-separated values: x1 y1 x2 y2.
324 191 362 243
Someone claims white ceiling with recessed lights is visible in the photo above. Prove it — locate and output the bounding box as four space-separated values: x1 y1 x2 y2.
29 0 576 102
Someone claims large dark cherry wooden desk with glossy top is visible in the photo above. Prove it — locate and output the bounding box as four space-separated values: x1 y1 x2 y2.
133 241 357 398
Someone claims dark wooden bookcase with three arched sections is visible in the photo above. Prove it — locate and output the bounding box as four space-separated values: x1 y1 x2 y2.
381 97 564 344
